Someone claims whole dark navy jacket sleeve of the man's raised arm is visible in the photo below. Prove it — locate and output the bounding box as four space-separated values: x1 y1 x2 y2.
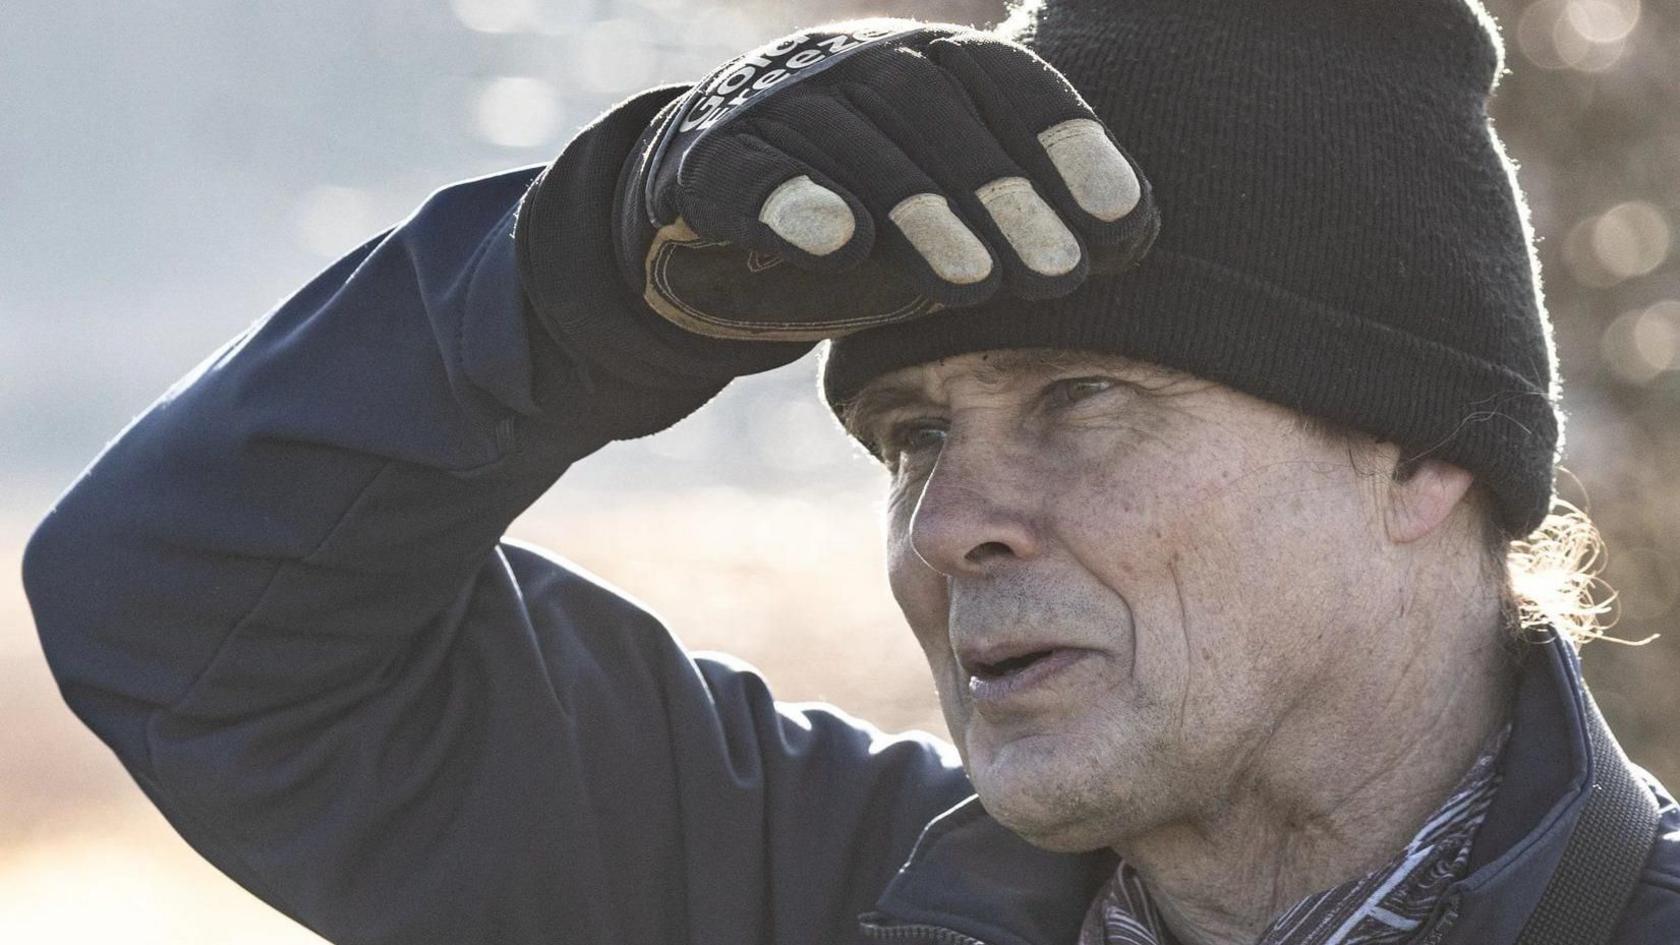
24 89 968 945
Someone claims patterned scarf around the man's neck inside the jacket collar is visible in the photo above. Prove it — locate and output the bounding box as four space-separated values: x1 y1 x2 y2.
1079 726 1510 945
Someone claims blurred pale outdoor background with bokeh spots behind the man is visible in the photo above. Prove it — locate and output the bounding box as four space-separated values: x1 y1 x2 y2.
0 0 1680 945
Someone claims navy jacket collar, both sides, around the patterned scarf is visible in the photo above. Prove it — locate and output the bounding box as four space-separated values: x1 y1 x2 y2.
864 636 1593 945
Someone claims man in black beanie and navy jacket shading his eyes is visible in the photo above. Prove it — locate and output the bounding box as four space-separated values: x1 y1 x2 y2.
25 0 1680 945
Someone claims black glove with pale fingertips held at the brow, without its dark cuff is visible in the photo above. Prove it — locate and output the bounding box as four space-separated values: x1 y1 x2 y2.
615 20 1159 341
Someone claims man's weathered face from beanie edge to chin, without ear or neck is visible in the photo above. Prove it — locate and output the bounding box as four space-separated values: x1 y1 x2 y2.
850 350 1393 849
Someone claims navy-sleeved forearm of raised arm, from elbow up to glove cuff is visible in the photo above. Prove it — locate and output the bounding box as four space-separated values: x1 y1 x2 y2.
16 102 726 749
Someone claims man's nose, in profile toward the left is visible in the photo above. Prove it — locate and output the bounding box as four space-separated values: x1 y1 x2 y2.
909 436 1038 577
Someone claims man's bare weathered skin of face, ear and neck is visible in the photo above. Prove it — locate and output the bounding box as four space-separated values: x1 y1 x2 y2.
848 351 1507 942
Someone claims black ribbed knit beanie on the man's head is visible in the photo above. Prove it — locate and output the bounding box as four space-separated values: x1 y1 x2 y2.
823 0 1561 536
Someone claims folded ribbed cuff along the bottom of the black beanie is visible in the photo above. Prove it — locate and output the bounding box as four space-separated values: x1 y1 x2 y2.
822 249 1557 535
